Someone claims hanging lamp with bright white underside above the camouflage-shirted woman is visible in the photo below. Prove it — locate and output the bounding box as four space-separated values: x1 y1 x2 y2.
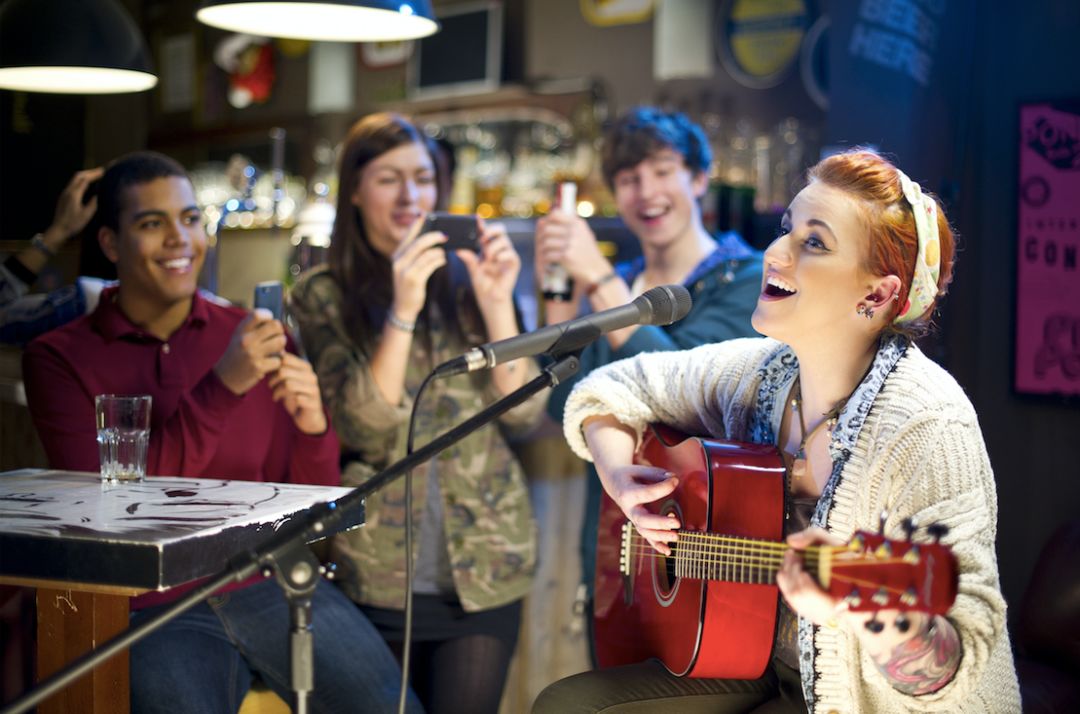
195 0 438 42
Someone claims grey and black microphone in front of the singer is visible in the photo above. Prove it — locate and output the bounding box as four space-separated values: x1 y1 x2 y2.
434 285 692 377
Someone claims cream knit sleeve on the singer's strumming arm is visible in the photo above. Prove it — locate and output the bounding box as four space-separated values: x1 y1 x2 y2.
563 338 771 460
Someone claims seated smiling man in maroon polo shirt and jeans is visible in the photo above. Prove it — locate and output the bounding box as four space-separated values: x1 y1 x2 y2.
23 152 419 714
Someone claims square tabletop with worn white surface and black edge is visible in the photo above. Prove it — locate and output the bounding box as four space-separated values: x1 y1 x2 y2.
0 469 362 590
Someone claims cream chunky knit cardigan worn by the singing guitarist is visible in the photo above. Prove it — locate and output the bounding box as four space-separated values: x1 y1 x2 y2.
564 339 1021 713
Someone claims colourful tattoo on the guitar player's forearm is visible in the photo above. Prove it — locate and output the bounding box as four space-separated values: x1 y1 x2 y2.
877 616 962 697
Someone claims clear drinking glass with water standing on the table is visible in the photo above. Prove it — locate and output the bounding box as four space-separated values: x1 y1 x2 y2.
94 394 152 481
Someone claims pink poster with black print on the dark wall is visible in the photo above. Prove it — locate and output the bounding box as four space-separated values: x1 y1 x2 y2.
1015 103 1080 395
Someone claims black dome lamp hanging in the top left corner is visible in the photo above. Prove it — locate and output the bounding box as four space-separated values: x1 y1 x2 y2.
0 0 158 94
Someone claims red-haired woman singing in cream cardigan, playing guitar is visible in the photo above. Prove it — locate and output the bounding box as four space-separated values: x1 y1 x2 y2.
535 151 1020 713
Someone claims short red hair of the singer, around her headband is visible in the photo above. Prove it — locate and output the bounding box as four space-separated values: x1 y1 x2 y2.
807 149 956 339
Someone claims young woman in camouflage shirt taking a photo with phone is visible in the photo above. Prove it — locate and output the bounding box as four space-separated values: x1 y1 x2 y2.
293 113 544 712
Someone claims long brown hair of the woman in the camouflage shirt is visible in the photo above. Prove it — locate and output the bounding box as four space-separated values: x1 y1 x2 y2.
327 112 480 350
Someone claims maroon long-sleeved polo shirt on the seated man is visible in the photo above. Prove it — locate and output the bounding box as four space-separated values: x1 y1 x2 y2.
23 287 341 607
